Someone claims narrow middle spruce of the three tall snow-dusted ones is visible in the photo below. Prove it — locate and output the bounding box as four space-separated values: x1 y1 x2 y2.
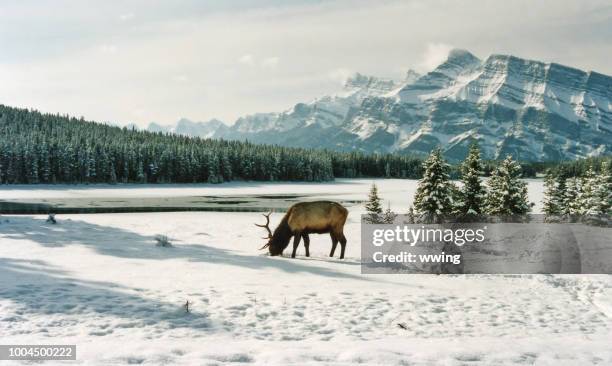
455 144 486 218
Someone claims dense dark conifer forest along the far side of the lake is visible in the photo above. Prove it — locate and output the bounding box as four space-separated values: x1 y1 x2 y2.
0 105 422 184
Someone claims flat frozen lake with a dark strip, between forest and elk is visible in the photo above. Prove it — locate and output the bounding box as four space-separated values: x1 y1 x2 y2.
0 179 543 214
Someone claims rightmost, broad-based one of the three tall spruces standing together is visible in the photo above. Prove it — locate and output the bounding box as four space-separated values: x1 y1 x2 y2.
485 155 531 217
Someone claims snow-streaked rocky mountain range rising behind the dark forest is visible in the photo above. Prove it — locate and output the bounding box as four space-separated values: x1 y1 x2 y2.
148 49 612 161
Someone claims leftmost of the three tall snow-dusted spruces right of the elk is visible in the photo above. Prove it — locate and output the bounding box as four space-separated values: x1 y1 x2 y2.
414 148 454 222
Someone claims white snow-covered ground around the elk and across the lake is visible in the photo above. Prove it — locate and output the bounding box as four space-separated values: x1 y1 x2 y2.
0 180 612 365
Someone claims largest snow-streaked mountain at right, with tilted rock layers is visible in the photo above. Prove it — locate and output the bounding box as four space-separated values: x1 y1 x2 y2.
356 50 612 160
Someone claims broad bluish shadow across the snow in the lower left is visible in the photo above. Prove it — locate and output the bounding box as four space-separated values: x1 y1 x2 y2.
0 258 211 337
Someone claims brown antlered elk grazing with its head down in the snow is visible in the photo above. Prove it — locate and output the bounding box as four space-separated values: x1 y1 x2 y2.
255 201 348 259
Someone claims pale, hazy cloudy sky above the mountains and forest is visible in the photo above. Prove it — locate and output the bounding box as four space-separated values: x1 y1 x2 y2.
0 0 612 127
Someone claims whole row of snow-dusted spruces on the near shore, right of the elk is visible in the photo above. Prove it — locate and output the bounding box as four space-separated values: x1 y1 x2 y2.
365 144 612 225
